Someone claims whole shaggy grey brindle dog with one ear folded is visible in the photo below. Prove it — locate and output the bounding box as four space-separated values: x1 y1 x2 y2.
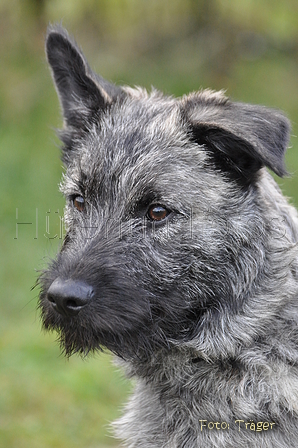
39 26 298 448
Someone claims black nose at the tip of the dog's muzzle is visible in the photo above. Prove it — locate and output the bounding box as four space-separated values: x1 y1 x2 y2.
47 277 93 317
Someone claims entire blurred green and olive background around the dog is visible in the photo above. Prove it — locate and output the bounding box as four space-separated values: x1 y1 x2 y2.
0 0 298 448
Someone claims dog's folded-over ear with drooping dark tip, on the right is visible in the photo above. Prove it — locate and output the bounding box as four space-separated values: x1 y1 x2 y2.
182 90 290 180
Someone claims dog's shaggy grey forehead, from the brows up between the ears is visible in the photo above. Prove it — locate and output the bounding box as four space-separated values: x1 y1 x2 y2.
63 91 211 206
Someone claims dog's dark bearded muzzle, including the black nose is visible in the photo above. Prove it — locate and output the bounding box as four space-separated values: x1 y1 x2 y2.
38 263 205 360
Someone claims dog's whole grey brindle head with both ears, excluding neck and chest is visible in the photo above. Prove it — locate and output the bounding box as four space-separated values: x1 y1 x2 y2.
40 28 289 359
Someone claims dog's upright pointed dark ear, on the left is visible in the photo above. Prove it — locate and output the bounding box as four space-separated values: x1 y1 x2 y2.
46 26 123 129
